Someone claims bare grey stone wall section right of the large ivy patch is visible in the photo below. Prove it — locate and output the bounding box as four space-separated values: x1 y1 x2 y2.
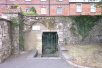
88 18 102 42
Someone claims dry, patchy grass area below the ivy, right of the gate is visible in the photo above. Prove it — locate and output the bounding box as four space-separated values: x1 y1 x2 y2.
66 43 102 68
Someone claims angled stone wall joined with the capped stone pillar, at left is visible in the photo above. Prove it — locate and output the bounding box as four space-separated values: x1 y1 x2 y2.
0 8 23 63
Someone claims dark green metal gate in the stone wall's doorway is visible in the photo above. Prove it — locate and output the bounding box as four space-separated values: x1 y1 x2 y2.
42 32 58 54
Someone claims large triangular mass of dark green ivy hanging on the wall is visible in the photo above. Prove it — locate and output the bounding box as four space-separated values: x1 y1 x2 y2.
70 15 101 41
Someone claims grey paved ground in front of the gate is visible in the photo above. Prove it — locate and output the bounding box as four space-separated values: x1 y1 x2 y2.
0 52 71 68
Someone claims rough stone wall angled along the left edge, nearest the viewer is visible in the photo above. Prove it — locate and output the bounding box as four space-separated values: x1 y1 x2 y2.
0 18 11 63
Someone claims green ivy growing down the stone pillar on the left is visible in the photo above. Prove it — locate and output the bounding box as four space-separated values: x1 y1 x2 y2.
10 15 23 53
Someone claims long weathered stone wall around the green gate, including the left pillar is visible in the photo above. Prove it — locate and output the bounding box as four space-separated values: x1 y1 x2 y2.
0 8 102 59
